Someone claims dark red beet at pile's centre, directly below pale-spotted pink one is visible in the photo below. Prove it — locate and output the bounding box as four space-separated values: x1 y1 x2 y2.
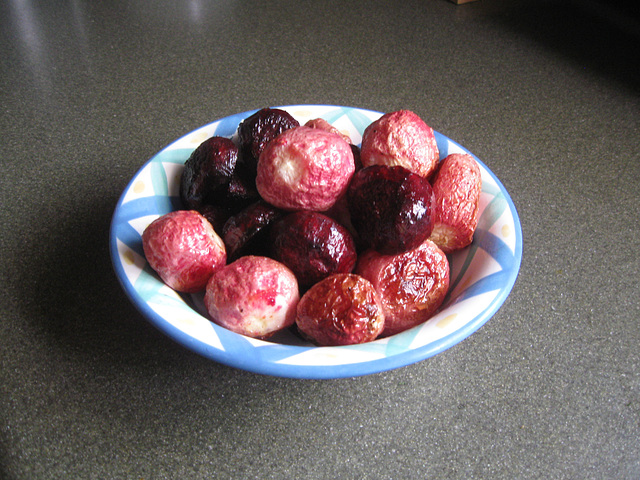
270 211 356 287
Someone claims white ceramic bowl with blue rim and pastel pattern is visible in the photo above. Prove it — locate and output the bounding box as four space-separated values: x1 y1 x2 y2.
109 105 522 379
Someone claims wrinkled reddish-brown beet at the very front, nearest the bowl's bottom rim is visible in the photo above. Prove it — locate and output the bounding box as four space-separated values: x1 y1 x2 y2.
296 273 384 346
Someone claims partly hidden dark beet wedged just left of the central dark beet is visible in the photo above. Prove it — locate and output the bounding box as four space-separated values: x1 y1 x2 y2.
222 200 284 260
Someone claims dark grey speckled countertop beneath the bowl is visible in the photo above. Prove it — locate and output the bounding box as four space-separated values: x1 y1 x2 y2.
0 0 640 480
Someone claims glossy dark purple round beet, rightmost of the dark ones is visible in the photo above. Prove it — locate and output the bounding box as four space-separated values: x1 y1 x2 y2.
347 165 434 254
